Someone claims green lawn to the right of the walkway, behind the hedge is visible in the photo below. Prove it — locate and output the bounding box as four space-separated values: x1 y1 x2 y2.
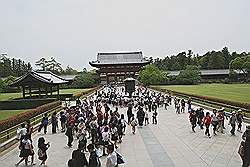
156 84 250 103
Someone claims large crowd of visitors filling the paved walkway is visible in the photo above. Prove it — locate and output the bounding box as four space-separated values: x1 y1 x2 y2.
16 86 250 167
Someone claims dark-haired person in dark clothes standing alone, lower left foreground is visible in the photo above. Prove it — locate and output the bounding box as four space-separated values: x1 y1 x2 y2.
38 137 50 166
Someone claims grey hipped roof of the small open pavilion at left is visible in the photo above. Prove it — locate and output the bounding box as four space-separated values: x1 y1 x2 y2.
10 71 69 86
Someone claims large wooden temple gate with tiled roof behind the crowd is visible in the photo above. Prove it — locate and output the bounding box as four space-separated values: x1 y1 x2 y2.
89 52 150 84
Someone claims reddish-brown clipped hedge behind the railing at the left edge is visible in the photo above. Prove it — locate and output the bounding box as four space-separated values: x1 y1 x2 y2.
0 101 62 131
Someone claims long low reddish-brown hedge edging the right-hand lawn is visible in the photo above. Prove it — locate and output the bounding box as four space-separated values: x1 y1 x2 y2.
150 87 250 111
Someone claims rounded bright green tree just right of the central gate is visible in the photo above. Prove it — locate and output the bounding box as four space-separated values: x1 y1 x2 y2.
139 64 168 86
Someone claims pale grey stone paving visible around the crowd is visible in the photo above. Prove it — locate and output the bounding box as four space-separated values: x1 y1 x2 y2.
0 103 245 167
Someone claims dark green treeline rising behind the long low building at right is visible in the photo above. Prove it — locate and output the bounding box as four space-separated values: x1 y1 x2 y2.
153 47 247 71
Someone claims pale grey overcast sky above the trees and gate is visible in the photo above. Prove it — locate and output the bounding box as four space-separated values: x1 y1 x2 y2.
0 0 250 70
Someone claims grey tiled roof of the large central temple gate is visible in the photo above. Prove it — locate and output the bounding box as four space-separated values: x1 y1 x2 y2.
90 52 149 66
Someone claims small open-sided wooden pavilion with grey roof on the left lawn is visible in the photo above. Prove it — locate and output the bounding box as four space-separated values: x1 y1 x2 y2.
10 71 69 98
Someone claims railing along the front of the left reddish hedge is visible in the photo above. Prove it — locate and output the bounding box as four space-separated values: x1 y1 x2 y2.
0 105 62 146
